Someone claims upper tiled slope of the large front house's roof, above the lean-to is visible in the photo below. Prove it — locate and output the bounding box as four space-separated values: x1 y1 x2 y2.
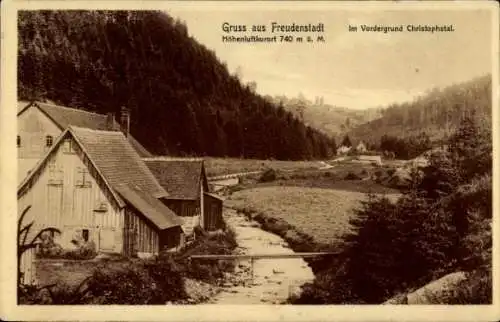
69 126 168 198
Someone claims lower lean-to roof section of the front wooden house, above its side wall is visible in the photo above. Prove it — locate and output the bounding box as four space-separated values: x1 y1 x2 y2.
115 185 184 229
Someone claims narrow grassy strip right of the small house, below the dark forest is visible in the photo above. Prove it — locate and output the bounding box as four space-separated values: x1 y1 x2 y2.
204 158 323 177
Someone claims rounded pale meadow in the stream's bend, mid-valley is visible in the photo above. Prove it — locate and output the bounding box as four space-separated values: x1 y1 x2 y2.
226 186 372 244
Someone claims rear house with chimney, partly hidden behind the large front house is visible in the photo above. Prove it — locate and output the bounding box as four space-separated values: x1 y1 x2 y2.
17 101 151 182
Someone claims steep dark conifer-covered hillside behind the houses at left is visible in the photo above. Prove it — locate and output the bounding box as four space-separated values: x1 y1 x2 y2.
18 11 335 159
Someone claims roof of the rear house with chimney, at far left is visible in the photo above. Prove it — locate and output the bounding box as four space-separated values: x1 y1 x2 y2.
17 102 152 157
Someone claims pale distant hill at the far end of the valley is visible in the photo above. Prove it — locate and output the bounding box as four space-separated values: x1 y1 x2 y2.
268 95 381 138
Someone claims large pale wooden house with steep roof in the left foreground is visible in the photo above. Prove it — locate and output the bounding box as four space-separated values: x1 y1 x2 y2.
18 126 187 257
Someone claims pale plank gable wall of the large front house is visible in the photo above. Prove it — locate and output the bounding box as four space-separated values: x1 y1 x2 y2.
18 135 124 252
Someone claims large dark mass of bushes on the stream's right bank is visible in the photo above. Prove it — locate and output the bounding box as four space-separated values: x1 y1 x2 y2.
295 195 456 304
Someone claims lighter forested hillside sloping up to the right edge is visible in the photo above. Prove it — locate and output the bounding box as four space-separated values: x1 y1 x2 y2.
349 75 491 144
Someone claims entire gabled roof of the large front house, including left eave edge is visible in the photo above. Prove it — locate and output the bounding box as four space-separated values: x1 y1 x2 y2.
18 126 180 229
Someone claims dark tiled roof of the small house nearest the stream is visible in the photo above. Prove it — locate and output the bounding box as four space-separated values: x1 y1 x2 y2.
143 158 205 200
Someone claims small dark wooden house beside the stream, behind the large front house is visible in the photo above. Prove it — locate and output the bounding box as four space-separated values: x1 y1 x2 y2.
143 157 223 235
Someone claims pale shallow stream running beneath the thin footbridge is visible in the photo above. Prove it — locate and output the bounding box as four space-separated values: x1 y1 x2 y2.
210 208 314 304
